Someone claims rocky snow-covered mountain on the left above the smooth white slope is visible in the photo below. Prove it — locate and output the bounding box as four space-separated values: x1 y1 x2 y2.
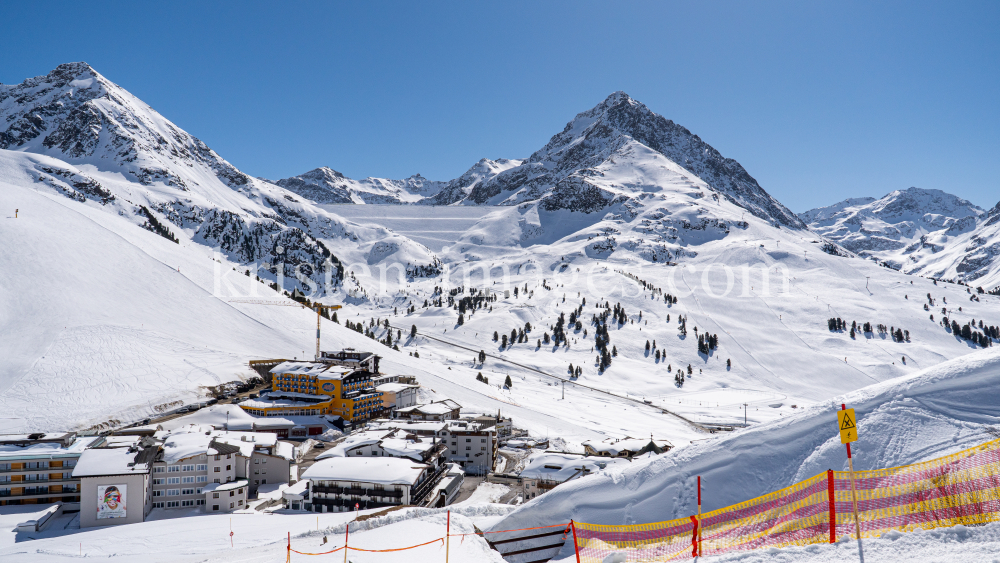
0 63 437 291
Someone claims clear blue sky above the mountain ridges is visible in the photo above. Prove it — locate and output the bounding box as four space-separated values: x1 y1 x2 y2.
0 1 1000 211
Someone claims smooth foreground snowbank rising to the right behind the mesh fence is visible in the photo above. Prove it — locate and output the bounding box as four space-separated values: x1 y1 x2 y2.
495 350 1000 540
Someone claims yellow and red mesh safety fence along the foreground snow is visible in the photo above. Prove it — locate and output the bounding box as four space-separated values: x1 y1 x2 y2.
572 440 1000 563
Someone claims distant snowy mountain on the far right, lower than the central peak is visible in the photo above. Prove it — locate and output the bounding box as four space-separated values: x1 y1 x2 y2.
799 188 984 272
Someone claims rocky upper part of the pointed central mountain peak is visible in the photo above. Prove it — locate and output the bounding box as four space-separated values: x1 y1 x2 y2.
458 92 805 228
